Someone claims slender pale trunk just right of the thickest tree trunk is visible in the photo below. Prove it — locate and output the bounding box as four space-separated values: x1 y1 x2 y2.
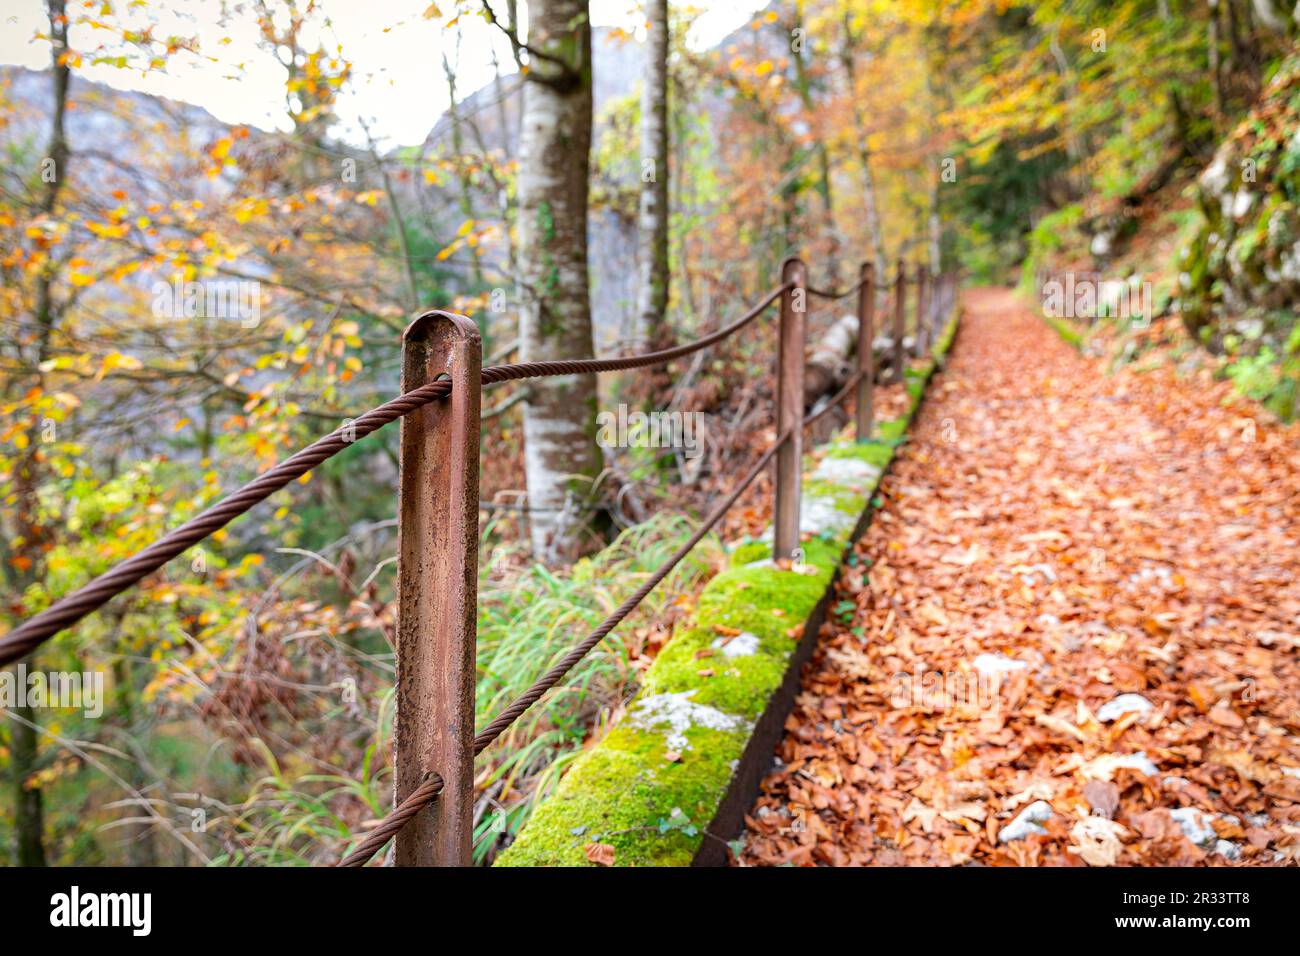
637 0 668 342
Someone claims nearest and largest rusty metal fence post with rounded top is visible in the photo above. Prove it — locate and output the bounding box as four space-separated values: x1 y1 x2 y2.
394 312 482 866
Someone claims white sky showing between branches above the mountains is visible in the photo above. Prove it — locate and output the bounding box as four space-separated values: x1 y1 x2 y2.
0 0 766 147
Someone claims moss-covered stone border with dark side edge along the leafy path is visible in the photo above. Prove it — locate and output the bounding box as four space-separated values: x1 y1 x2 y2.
495 310 958 866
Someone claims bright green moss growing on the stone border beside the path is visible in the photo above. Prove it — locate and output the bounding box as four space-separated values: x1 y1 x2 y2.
497 312 956 866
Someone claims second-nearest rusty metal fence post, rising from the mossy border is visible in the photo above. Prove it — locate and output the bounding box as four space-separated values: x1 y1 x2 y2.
772 256 807 558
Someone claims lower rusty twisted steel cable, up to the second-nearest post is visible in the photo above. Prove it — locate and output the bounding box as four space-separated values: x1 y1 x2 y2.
338 419 790 866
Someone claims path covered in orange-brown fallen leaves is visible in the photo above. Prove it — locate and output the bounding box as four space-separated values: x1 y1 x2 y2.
741 289 1300 865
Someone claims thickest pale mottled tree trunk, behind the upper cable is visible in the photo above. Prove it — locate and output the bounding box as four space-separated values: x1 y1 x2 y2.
519 0 602 563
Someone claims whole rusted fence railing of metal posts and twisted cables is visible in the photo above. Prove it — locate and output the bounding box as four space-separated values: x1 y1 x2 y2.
0 258 957 866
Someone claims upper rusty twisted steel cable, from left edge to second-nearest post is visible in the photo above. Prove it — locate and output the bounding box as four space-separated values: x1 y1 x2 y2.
0 282 790 665
